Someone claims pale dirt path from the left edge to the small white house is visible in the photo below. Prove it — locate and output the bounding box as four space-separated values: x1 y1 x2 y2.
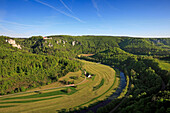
0 76 86 97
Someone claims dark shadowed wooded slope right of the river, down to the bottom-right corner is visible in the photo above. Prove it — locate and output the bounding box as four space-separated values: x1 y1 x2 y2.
81 48 170 113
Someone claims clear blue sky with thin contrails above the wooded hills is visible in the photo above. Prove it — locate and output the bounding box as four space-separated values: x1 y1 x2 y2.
0 0 170 37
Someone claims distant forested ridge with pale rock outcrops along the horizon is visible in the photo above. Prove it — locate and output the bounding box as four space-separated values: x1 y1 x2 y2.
14 35 170 57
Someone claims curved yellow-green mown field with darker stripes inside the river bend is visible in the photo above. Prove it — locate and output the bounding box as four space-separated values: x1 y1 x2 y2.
0 60 119 113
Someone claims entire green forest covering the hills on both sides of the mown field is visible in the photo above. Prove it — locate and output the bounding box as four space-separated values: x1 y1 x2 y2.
0 35 170 113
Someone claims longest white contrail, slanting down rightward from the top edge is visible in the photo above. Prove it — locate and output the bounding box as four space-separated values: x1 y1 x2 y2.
35 0 84 23
